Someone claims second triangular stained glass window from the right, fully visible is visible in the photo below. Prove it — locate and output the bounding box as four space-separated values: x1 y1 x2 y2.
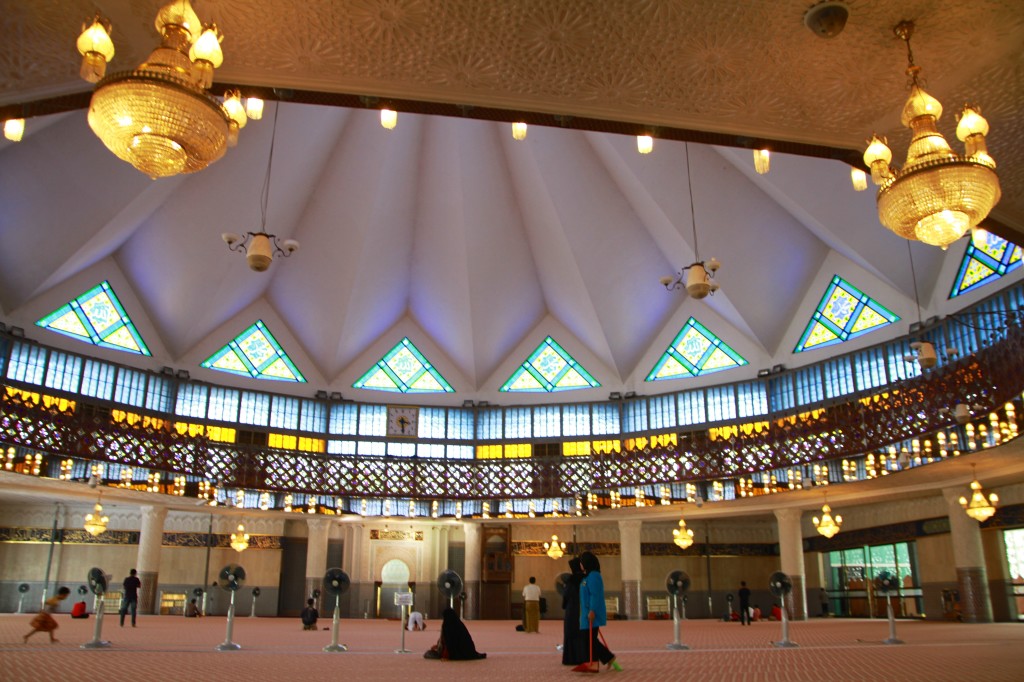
793 274 899 353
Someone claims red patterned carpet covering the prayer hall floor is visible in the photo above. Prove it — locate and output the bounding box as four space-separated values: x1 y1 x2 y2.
0 614 1024 682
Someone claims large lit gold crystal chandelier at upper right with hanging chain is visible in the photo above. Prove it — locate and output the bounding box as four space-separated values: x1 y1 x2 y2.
864 22 999 249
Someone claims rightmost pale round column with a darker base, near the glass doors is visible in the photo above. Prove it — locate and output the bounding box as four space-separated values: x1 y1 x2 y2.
942 487 992 623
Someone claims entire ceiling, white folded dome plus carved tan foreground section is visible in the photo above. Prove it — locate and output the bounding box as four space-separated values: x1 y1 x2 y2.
0 0 1024 404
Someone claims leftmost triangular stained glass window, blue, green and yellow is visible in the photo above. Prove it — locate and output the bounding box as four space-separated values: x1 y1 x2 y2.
36 281 153 355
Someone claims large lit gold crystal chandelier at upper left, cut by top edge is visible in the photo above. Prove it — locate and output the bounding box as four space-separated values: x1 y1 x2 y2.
77 0 253 179
